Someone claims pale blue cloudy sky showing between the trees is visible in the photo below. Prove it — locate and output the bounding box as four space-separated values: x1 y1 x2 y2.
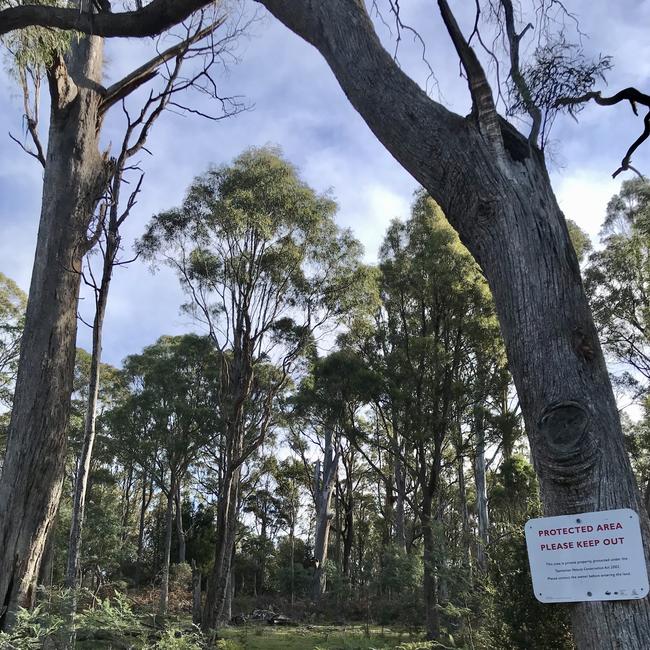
0 0 650 364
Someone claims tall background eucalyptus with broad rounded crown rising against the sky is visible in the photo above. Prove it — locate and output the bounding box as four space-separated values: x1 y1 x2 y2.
141 148 365 628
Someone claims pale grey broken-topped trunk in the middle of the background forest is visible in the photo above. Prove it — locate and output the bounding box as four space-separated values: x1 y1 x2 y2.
312 429 339 601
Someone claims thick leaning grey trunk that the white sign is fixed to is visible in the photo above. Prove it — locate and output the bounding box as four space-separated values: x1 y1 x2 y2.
262 0 650 650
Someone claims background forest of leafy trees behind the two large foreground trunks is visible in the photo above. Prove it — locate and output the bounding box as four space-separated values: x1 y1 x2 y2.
2 149 650 648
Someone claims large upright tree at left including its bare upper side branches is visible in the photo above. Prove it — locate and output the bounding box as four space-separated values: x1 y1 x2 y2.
0 0 238 629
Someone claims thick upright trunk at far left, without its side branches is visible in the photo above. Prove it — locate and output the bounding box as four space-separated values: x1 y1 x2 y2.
0 31 108 629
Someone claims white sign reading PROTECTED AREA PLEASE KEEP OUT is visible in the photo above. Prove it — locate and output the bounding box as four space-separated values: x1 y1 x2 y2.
525 508 648 603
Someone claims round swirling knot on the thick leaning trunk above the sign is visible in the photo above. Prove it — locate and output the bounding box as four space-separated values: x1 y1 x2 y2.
537 400 600 485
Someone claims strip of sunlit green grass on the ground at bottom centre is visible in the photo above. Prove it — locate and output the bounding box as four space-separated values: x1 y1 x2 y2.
219 624 426 650
